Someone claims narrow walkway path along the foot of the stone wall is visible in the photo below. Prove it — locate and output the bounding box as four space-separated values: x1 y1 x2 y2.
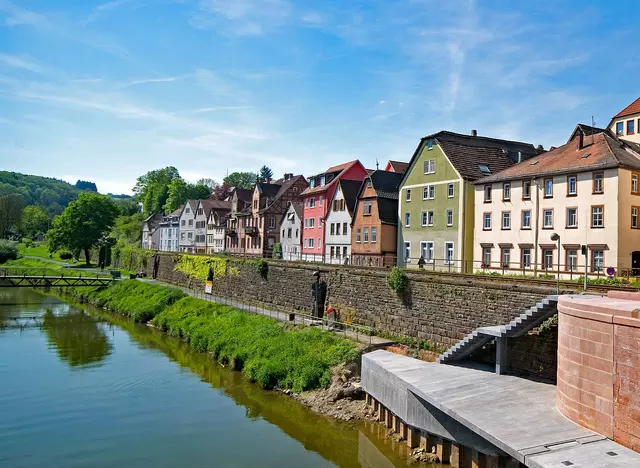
139 278 394 347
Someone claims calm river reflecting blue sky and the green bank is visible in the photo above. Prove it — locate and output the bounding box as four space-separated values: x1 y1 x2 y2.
0 288 440 468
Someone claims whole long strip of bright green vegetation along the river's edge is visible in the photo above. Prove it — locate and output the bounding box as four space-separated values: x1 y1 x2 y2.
74 280 359 392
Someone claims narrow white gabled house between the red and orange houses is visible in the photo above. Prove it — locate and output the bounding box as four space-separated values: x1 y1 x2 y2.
324 179 362 264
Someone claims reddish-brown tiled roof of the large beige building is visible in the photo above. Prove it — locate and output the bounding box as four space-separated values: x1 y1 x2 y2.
476 131 640 184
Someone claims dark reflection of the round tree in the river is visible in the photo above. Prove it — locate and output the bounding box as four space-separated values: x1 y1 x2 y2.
42 309 112 367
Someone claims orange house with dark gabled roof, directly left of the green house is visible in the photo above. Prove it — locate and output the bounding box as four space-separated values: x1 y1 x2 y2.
351 171 402 267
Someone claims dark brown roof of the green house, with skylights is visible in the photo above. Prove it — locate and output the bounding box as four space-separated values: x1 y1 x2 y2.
403 130 542 185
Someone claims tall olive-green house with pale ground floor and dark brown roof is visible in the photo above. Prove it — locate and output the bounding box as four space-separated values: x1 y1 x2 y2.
398 130 542 272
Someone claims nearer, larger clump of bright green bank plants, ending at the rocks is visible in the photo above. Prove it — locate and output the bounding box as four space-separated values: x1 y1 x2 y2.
153 297 358 391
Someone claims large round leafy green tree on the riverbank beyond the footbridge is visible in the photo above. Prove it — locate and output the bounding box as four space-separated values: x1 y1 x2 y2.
47 192 118 264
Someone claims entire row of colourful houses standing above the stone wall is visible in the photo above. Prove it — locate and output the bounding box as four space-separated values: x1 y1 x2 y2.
143 99 640 275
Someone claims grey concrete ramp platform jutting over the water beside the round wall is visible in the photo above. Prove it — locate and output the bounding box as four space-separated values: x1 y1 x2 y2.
362 351 640 468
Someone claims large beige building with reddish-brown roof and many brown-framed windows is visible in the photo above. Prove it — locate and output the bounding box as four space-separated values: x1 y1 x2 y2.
473 125 640 277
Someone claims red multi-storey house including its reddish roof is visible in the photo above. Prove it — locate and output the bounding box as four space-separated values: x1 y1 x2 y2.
302 160 368 261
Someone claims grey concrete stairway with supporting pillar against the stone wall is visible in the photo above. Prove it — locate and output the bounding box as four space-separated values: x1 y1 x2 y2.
436 296 558 374
